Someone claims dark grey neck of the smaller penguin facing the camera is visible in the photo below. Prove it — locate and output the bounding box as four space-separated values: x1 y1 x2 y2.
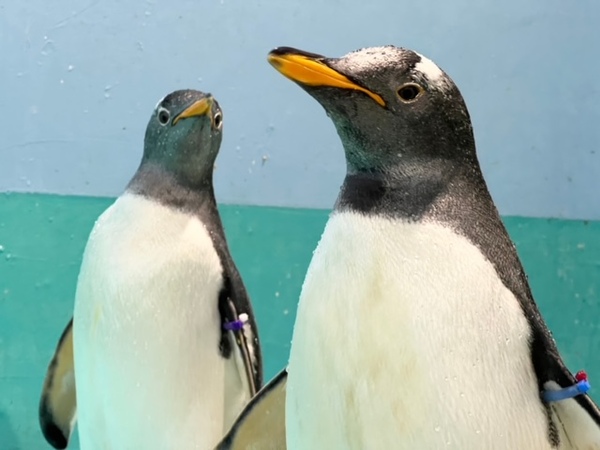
126 162 219 220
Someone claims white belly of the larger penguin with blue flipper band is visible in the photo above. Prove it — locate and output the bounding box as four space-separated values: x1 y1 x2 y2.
286 213 550 450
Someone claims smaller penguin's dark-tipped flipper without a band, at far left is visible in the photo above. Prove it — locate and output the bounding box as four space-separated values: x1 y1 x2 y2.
38 318 77 449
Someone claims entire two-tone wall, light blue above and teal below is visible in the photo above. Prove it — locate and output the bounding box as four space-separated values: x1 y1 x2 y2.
0 0 600 450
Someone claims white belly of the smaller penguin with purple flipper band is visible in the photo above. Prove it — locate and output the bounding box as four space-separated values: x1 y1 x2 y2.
73 194 248 450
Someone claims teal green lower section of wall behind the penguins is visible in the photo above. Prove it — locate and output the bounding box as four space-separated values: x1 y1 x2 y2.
0 194 600 450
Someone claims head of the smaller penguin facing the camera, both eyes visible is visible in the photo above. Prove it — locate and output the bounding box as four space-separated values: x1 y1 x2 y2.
142 90 223 186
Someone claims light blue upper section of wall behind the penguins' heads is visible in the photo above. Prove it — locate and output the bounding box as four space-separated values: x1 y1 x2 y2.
0 0 600 219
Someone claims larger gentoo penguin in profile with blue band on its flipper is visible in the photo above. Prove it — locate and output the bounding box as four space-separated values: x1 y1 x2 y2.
219 46 600 450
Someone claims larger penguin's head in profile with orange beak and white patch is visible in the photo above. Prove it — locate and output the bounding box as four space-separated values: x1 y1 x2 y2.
268 46 475 173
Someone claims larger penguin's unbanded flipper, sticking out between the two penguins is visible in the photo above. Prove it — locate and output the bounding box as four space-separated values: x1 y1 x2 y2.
215 369 287 450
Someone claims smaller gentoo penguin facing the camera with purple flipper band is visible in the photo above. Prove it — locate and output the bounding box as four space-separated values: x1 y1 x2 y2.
40 90 262 450
